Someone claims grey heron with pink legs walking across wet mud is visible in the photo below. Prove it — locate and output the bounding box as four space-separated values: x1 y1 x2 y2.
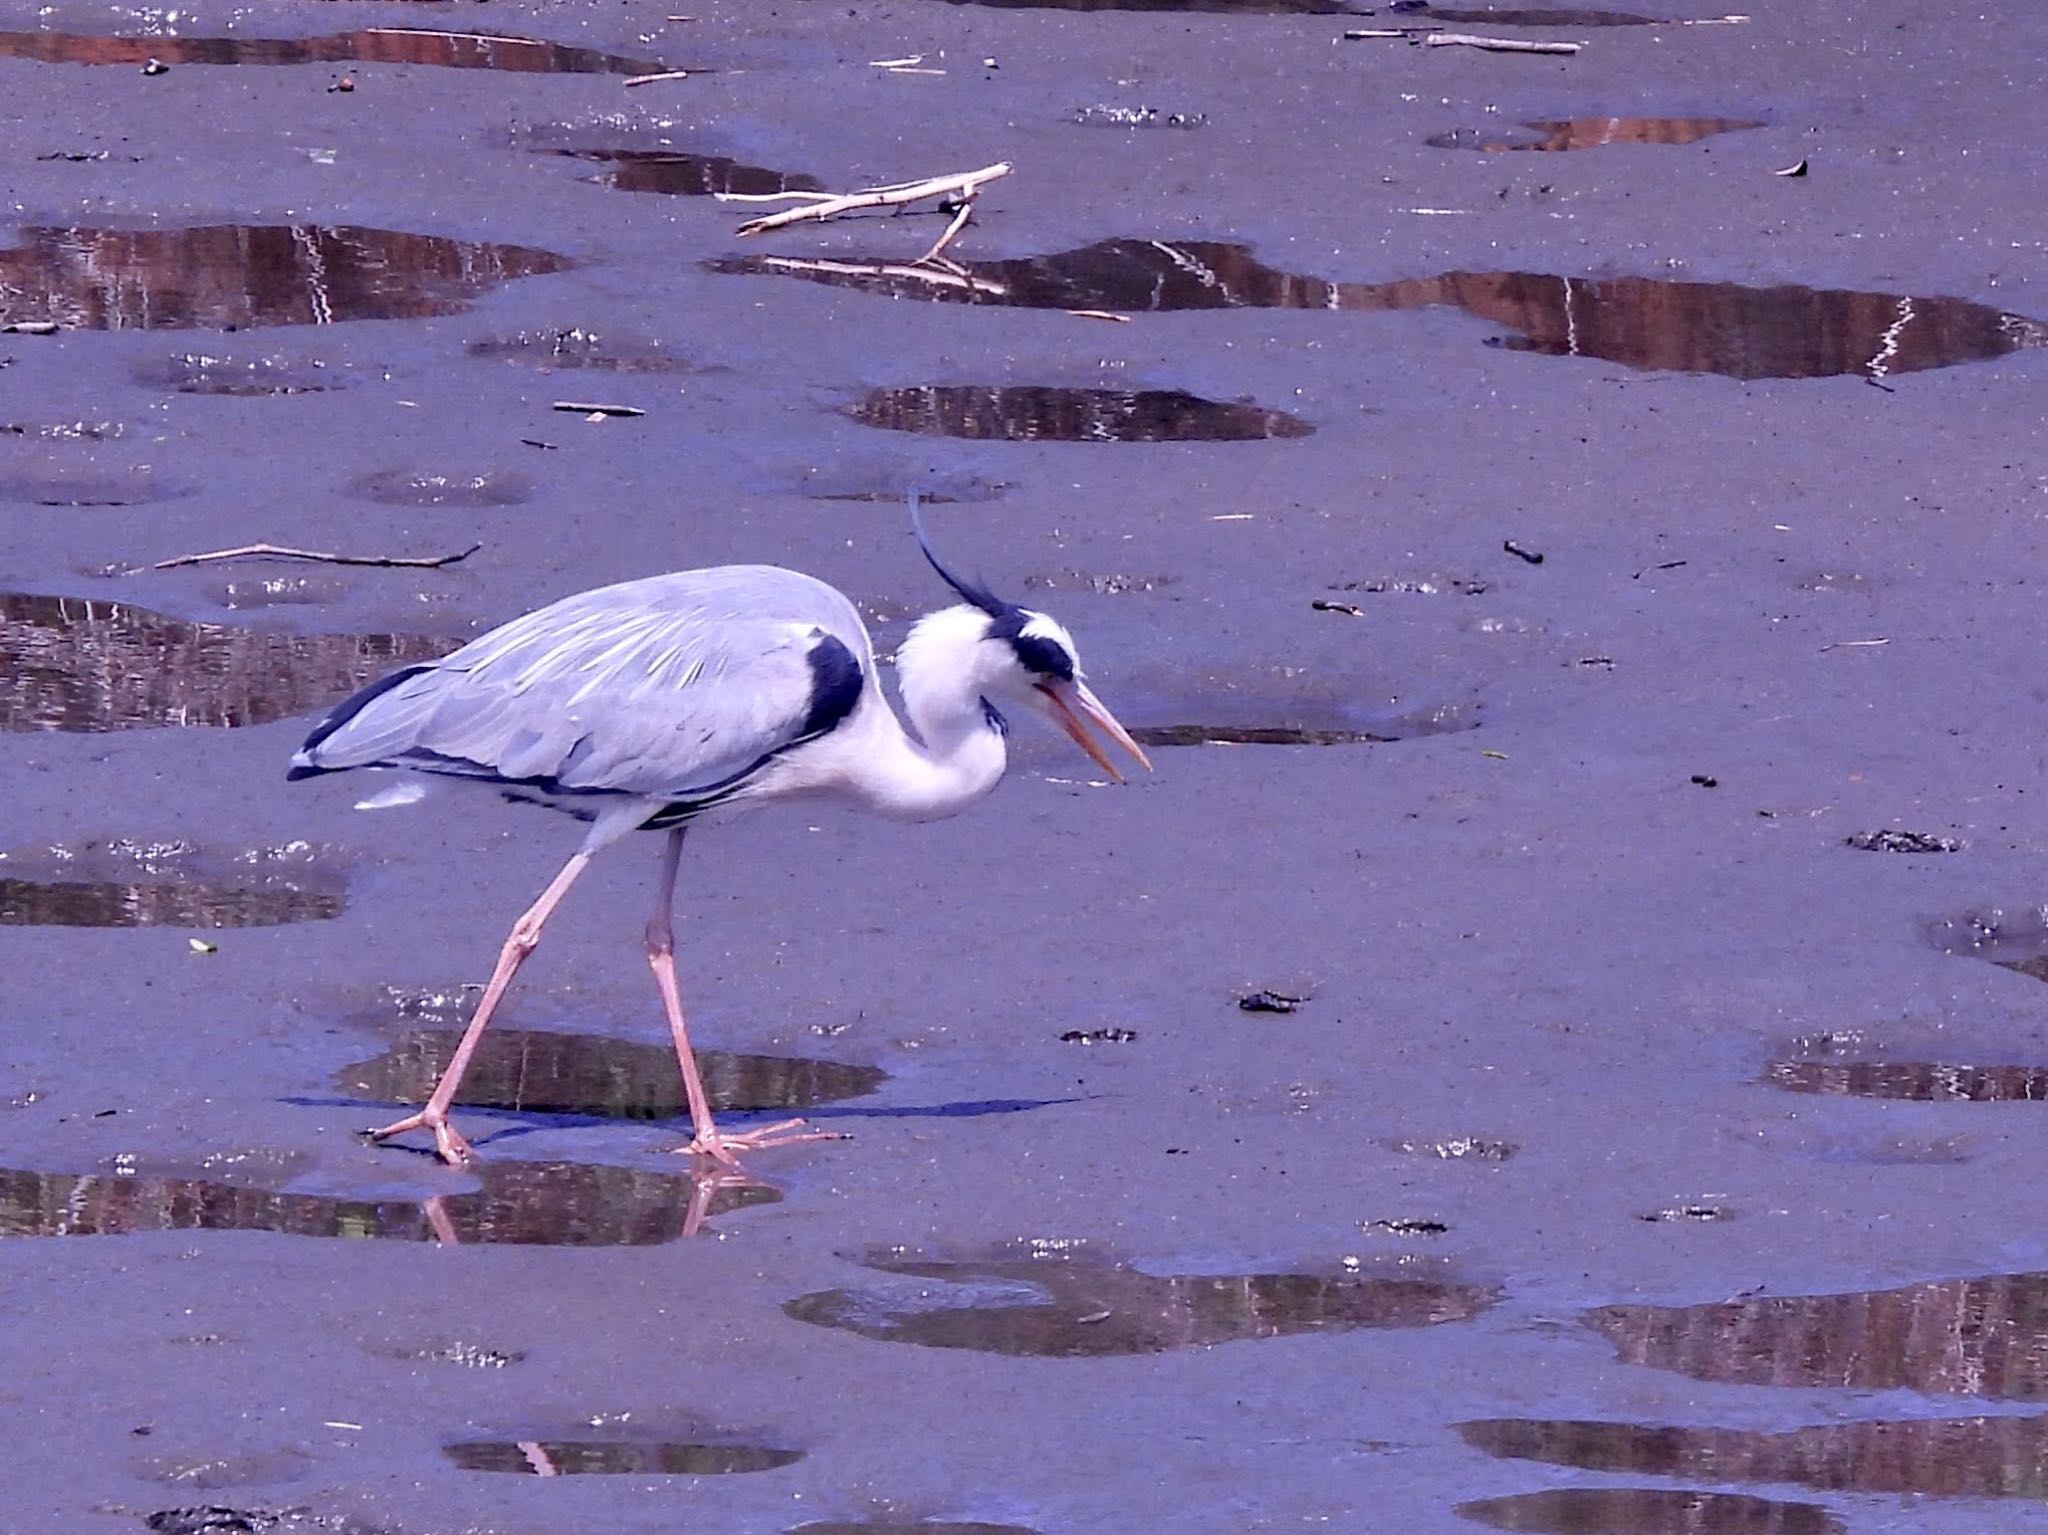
289 523 1151 1167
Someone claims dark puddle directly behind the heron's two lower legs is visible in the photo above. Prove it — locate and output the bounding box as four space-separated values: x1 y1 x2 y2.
334 1029 889 1120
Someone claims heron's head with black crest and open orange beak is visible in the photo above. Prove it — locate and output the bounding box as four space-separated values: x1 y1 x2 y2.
897 503 1151 782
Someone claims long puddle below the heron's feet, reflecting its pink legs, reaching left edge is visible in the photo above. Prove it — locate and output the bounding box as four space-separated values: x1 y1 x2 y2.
0 1160 782 1246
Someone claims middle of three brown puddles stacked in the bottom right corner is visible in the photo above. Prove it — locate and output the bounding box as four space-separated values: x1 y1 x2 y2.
1458 1418 2048 1506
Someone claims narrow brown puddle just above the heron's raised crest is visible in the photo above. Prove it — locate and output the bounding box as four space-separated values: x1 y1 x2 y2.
848 385 1315 442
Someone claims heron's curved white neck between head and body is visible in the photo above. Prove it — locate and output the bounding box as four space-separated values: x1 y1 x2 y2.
854 608 1010 821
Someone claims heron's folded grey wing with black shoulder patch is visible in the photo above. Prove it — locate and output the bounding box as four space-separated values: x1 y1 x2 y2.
293 565 874 798
